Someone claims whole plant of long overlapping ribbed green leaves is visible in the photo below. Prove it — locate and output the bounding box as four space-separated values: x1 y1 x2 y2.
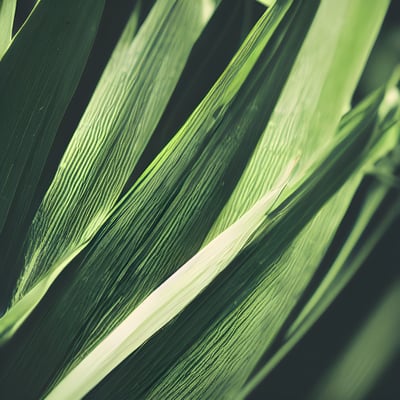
0 0 400 399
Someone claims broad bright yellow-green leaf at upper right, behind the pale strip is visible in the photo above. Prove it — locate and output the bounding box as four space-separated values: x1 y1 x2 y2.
206 0 390 242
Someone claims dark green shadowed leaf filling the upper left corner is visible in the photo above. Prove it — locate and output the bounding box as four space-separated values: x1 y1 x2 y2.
0 0 103 234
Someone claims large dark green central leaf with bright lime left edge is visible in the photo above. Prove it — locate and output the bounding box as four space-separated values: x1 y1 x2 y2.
1 1 318 396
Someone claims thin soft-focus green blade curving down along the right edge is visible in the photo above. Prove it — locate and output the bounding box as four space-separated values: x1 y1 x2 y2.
286 83 400 337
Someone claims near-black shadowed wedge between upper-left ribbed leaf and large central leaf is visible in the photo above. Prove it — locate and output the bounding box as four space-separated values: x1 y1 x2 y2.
136 0 263 172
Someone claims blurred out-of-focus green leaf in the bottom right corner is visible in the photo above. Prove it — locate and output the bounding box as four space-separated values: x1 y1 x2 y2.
309 280 400 400
